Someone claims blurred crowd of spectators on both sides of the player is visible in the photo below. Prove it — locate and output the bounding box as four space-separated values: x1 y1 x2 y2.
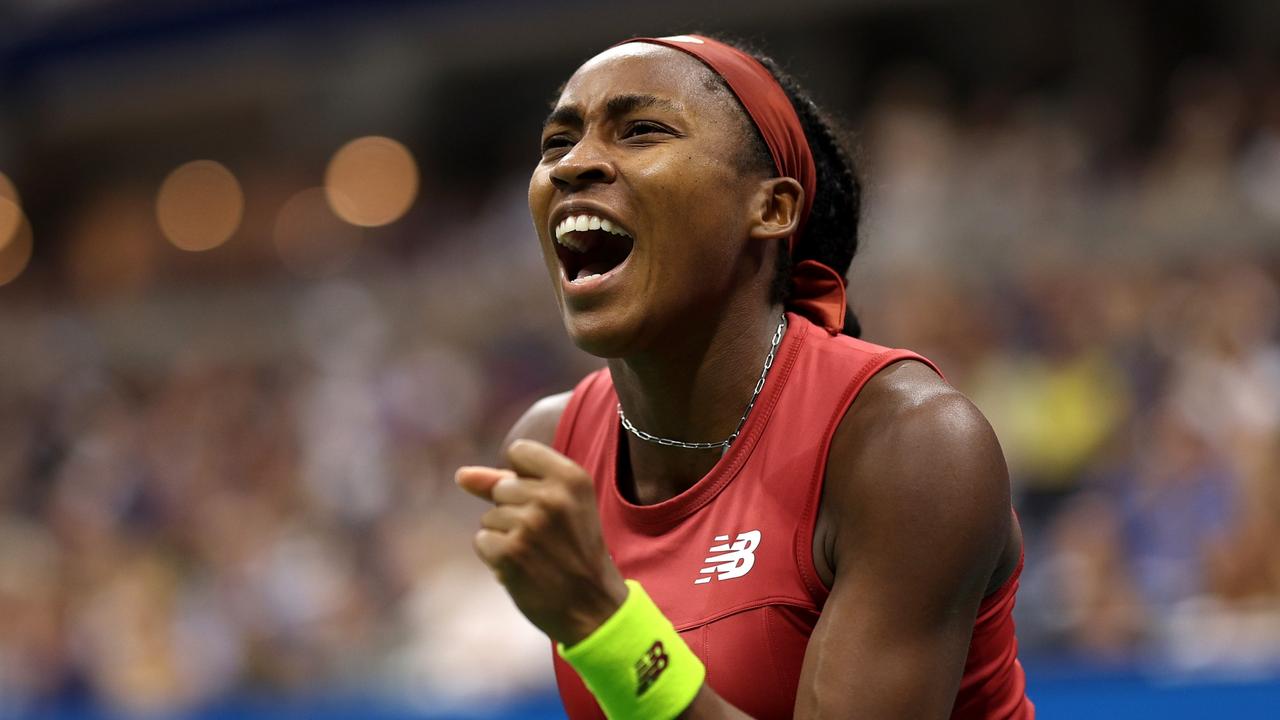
0 54 1280 715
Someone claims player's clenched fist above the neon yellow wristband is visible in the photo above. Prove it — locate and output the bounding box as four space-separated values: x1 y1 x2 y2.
456 439 627 646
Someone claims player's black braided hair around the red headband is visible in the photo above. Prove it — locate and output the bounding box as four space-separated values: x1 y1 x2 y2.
707 38 863 337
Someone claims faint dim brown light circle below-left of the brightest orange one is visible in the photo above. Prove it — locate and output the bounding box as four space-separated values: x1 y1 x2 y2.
274 187 361 278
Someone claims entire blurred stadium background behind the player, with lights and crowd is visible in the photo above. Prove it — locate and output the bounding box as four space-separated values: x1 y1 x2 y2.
0 0 1280 719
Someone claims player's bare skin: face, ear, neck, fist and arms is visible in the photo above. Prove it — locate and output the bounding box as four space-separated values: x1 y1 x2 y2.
457 45 1021 719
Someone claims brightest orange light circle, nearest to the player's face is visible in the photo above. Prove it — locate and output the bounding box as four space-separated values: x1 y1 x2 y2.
324 136 419 228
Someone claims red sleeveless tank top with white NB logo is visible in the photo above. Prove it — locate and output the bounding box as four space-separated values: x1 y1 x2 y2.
554 313 1033 720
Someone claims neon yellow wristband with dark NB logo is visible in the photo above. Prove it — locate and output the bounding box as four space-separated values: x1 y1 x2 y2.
556 580 707 720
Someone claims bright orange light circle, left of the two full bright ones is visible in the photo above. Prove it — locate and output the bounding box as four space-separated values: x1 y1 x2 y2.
156 160 244 252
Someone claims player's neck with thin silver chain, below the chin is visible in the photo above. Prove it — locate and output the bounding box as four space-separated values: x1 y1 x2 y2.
609 299 782 503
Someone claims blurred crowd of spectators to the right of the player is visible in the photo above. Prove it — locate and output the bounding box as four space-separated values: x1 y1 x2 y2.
854 63 1280 675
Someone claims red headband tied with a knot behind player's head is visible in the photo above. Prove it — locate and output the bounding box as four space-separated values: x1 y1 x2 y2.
618 35 845 334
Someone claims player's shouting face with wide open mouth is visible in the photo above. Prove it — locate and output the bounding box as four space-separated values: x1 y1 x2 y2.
529 42 765 357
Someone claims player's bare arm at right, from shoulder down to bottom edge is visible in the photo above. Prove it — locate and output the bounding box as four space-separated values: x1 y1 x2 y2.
796 363 1011 717
